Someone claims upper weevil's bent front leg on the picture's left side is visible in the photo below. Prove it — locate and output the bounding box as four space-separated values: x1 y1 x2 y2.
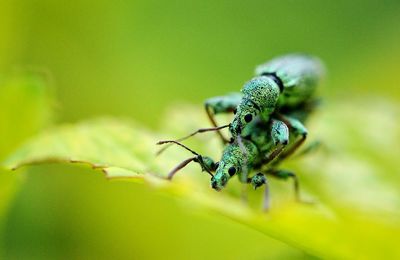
204 93 242 144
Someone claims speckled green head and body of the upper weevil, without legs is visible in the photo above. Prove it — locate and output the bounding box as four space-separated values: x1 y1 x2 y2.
229 54 323 138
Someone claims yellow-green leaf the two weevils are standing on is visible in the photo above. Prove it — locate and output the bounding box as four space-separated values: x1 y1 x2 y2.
5 100 400 259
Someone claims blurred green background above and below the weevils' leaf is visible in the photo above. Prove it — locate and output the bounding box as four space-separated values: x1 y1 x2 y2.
0 0 400 259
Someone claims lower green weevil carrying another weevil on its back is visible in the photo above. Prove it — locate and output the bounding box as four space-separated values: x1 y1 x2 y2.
158 112 308 210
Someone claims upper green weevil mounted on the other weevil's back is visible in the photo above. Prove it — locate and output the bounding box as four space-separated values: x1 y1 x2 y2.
160 54 324 159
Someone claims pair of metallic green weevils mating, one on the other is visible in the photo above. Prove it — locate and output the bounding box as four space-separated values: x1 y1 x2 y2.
158 54 323 208
